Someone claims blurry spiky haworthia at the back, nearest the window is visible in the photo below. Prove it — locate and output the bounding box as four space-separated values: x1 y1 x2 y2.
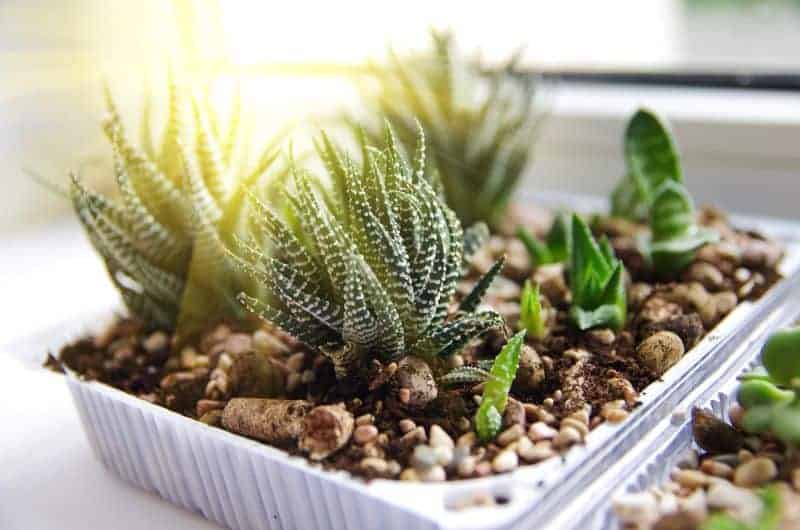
363 31 539 225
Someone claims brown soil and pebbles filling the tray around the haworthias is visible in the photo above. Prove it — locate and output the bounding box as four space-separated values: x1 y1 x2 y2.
49 205 782 482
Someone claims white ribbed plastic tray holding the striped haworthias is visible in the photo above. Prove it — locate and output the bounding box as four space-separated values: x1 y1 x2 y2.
12 201 800 530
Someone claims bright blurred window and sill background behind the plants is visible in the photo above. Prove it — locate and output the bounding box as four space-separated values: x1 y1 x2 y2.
0 0 800 234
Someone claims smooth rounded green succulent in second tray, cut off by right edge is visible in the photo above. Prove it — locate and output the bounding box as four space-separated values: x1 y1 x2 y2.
737 328 800 447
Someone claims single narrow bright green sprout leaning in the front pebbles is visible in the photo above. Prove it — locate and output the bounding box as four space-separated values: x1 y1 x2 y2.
475 330 525 442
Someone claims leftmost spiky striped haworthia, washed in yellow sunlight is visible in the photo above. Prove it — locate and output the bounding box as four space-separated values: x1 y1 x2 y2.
70 82 286 337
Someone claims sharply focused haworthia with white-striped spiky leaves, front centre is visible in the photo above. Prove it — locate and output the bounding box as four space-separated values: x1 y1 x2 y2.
238 126 503 378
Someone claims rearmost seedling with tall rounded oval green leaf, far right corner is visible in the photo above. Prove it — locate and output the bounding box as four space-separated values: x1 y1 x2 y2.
611 109 683 221
